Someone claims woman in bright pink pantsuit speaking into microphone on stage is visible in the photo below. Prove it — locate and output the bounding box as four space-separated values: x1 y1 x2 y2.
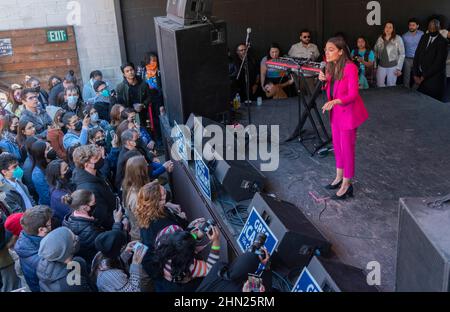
319 37 369 200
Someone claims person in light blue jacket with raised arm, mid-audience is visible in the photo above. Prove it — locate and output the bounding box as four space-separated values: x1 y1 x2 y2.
62 113 91 150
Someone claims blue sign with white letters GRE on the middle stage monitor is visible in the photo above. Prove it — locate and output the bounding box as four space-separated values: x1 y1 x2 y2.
237 207 278 255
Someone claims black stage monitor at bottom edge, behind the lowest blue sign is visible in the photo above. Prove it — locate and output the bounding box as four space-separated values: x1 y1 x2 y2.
307 256 378 292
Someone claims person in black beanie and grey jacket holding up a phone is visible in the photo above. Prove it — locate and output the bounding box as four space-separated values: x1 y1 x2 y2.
91 231 145 292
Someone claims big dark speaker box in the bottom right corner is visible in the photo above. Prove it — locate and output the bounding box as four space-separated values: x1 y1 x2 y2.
396 198 450 292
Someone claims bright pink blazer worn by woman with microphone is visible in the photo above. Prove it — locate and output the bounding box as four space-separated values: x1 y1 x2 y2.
326 62 369 130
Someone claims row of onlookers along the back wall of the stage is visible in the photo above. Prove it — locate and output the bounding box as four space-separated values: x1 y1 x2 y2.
229 18 450 101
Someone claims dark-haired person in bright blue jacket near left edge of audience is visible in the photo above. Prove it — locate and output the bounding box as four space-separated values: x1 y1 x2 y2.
31 141 58 206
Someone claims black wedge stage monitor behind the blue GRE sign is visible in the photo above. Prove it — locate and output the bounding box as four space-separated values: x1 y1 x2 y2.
248 193 331 268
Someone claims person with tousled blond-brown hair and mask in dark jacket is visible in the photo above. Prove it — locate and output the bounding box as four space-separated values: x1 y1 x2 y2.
72 144 116 230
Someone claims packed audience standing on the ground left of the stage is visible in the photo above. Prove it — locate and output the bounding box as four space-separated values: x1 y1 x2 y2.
0 55 268 292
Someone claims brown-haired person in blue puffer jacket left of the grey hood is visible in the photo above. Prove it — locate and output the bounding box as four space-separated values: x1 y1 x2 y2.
14 206 52 292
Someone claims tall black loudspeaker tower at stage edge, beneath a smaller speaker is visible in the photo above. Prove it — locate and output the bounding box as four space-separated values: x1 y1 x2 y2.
155 17 230 124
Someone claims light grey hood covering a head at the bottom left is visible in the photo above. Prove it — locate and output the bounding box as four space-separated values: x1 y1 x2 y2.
38 226 75 262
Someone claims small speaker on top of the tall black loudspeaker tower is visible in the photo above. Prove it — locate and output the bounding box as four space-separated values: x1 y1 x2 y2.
167 0 212 25
